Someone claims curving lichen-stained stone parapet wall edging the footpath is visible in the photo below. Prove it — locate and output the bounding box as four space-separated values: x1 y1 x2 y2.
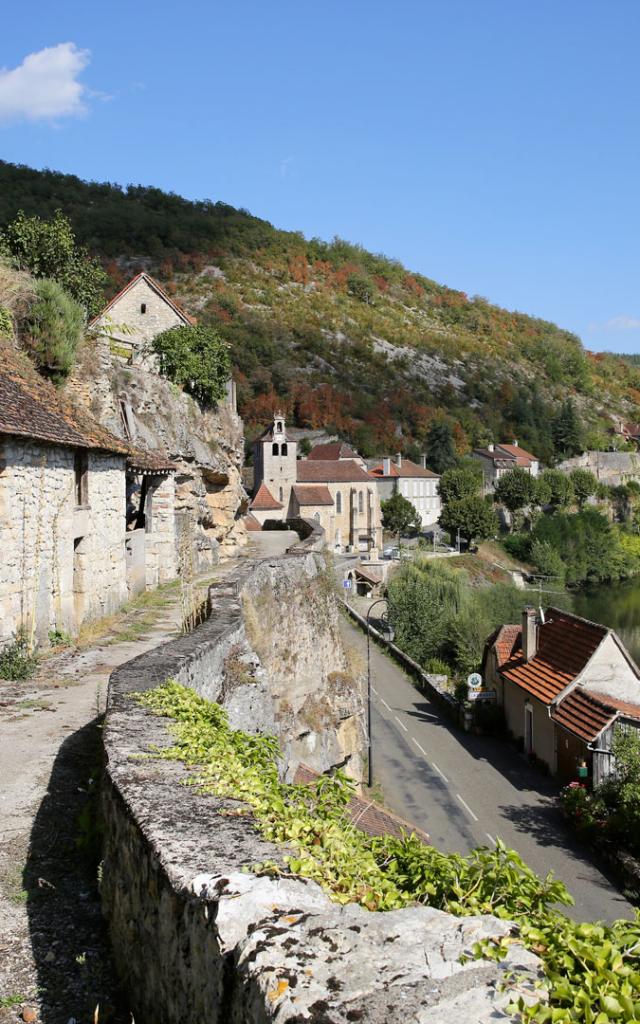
102 556 541 1024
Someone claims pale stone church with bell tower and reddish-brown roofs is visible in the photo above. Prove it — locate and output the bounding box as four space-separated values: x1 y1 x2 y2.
248 413 382 555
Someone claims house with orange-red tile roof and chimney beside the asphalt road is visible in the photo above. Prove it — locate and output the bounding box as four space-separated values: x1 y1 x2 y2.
484 607 640 785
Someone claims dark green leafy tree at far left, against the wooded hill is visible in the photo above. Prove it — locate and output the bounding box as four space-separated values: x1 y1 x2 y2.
0 210 109 316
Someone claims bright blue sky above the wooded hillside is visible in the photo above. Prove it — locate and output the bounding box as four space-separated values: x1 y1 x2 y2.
0 0 640 351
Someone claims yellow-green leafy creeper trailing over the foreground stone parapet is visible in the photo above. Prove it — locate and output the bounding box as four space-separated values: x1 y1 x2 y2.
135 681 640 1024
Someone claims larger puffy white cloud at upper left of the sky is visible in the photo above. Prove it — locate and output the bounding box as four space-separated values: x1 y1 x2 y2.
0 43 90 121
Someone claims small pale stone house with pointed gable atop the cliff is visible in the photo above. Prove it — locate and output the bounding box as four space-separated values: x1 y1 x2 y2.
91 272 195 365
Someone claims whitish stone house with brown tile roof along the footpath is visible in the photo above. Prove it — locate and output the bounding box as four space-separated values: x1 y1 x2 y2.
0 346 176 643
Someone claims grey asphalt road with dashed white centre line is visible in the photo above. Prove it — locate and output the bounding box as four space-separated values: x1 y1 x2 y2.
342 618 633 921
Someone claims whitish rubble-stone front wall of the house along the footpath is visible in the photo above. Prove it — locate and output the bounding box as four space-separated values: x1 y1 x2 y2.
0 437 127 642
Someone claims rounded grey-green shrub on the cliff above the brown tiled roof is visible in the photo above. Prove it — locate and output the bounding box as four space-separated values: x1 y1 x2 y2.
20 278 85 384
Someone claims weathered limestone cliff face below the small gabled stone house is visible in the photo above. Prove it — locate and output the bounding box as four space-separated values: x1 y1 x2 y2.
69 339 247 571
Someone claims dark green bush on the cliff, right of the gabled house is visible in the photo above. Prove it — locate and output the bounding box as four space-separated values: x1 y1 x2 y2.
153 327 231 404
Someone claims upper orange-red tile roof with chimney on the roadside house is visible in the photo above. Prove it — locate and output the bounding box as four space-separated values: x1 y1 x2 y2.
500 608 608 705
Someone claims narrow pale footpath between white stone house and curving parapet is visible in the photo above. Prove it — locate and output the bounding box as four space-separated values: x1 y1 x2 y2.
0 562 236 1024
